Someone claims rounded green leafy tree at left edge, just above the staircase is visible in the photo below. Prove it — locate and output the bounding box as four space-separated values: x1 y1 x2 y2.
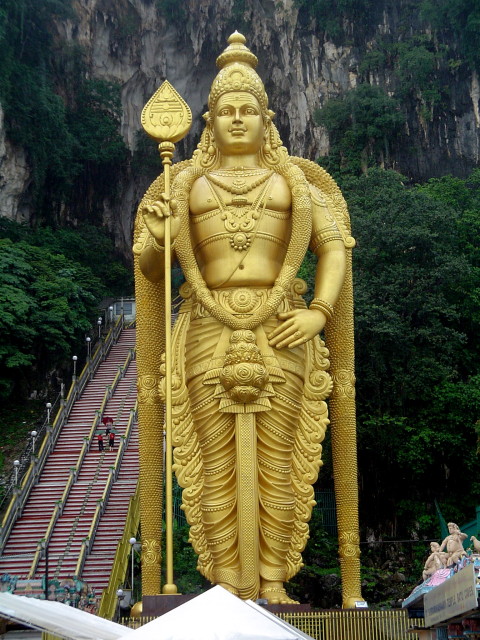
0 238 102 398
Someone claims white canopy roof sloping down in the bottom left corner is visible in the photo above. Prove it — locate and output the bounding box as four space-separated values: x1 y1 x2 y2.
0 593 131 640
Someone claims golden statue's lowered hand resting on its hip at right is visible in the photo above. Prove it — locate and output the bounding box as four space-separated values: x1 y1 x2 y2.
267 309 327 349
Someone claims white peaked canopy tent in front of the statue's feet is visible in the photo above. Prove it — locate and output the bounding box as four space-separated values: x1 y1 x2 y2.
117 586 312 640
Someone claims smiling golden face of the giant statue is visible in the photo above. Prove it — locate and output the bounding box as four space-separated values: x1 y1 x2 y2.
213 91 265 155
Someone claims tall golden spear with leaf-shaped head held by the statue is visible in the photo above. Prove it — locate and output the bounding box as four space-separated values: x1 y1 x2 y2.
142 80 192 594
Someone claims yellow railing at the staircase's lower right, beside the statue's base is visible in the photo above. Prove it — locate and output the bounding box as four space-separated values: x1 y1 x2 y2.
97 483 140 620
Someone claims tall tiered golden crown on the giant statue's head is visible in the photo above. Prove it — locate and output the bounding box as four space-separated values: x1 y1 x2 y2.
208 31 268 113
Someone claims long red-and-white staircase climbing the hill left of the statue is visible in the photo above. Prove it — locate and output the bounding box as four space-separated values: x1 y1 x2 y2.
0 329 138 597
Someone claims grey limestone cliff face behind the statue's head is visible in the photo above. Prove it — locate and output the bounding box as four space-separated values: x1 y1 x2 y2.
0 0 480 254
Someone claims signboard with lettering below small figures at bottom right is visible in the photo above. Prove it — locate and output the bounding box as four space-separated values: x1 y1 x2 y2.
424 564 477 627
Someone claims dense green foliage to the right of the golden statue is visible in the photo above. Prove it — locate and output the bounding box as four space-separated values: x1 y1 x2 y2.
342 170 480 537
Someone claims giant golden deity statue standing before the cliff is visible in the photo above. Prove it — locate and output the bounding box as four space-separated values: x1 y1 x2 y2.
134 33 362 606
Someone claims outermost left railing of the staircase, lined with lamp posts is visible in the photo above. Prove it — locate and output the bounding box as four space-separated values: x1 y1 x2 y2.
0 314 125 554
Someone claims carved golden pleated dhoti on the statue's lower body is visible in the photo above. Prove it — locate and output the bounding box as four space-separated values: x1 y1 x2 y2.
174 289 331 598
